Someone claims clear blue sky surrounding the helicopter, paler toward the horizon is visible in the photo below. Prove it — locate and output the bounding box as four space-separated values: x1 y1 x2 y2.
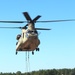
0 0 75 72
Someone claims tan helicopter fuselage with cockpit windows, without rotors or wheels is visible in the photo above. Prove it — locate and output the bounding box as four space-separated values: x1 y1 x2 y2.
16 24 40 51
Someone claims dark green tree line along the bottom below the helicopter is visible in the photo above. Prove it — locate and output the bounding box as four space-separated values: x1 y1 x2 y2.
0 68 75 75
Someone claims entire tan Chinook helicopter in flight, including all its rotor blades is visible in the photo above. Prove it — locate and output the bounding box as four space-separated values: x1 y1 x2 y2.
0 12 75 54
